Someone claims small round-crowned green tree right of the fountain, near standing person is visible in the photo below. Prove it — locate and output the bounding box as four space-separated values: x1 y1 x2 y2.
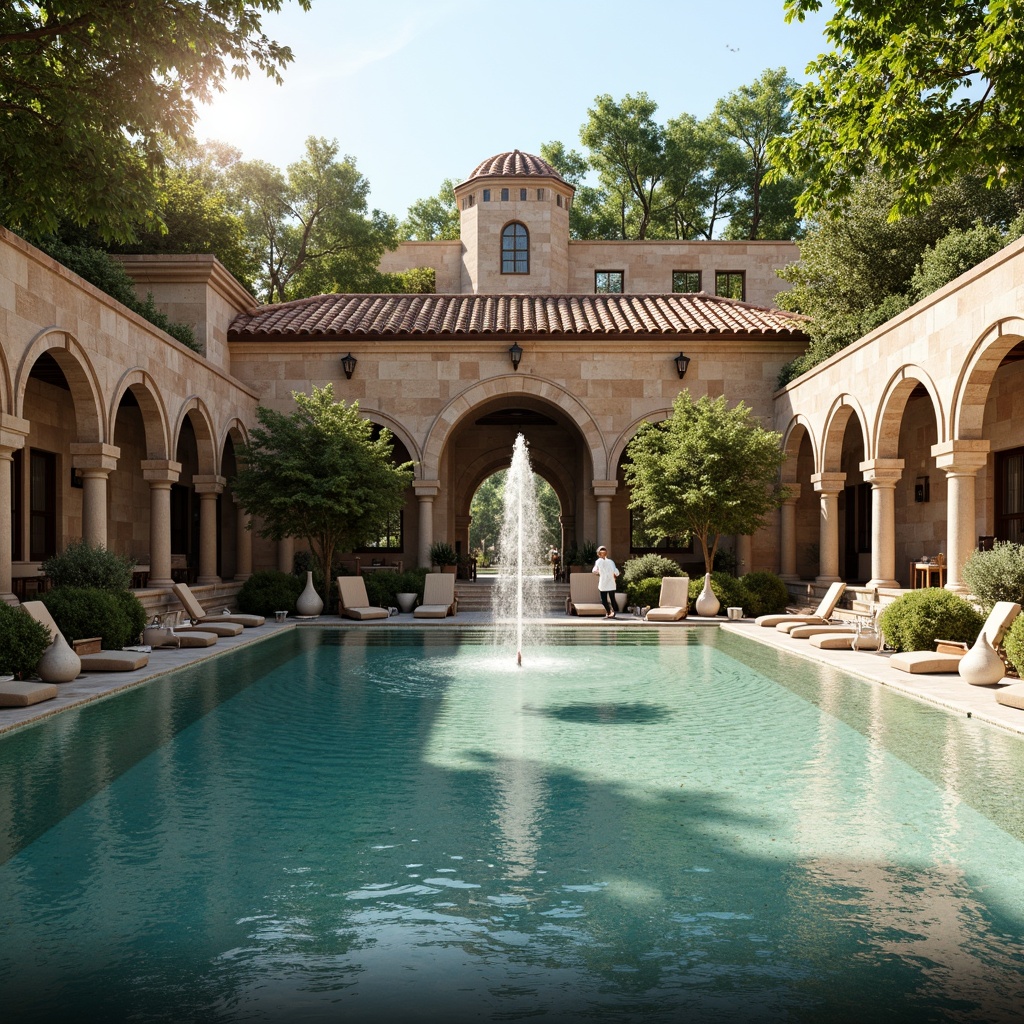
625 391 786 572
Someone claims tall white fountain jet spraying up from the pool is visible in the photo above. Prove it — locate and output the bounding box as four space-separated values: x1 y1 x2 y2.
493 434 544 665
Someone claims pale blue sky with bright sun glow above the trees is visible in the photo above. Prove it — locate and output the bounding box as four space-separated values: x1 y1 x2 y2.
197 0 827 217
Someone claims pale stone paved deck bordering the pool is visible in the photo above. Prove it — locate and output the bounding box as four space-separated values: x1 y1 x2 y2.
0 611 1024 736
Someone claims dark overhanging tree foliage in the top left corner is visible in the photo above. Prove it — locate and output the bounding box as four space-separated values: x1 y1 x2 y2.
0 0 310 242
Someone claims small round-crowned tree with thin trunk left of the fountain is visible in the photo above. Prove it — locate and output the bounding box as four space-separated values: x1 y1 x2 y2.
233 384 413 602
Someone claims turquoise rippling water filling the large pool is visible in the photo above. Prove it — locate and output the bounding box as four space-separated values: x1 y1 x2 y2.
0 629 1024 1022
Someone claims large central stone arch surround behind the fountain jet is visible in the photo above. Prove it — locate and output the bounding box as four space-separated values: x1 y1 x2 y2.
417 374 608 480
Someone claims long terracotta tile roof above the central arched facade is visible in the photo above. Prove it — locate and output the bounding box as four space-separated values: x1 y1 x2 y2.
228 292 806 341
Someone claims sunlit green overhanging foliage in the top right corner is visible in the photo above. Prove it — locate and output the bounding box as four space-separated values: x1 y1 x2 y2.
773 0 1024 216
